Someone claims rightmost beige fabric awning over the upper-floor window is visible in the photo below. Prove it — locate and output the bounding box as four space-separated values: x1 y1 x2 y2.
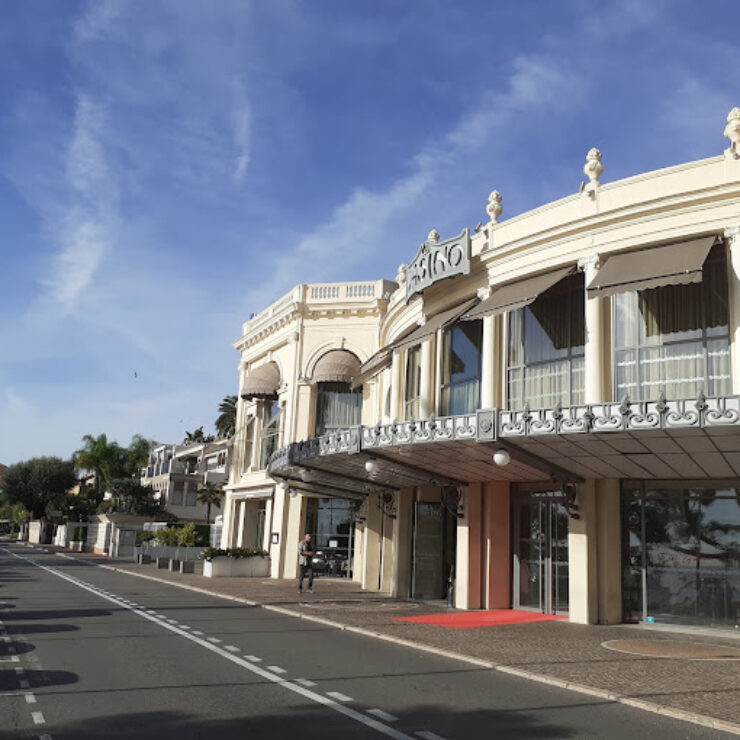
586 236 716 298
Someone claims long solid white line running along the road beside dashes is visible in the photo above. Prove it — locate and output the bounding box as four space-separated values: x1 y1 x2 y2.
3 548 413 740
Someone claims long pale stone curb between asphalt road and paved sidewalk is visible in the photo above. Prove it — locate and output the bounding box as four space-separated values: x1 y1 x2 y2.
52 553 740 735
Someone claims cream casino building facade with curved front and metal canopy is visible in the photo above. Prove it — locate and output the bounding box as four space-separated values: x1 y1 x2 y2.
224 109 740 627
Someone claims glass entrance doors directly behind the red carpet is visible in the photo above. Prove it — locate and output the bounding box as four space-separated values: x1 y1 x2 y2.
512 491 568 614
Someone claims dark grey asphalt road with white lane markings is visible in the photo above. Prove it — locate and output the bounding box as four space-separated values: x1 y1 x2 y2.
0 542 731 740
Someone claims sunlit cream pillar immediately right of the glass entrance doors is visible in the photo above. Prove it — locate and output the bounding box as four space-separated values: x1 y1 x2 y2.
568 480 599 624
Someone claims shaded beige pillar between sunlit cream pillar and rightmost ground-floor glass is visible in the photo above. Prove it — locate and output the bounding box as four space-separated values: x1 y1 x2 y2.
595 480 622 624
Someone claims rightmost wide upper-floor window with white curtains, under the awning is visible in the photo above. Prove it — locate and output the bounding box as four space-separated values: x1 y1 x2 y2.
614 246 731 400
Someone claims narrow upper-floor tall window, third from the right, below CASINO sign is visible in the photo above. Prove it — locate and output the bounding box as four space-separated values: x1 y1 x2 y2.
442 319 483 415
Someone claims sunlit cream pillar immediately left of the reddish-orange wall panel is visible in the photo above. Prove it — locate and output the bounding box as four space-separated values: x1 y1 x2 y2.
455 483 483 609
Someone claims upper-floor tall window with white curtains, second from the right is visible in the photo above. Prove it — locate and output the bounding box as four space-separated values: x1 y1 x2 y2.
508 273 586 409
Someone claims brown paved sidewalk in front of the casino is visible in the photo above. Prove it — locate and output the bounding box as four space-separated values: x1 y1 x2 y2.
39 548 740 735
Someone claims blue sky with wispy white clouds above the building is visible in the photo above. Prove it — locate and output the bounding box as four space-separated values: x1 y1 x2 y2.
0 0 740 463
